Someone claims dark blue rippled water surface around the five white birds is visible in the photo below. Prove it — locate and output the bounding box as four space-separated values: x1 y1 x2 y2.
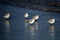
0 4 60 40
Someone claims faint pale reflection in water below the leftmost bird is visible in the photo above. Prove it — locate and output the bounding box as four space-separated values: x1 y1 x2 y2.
4 19 10 40
